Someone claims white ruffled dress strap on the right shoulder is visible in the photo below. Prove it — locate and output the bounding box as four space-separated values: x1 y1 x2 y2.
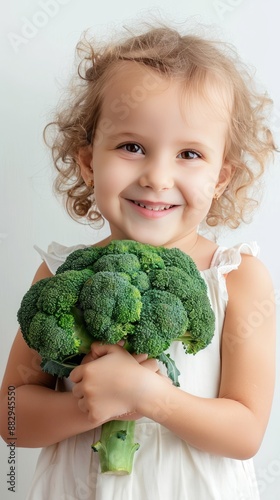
210 241 259 274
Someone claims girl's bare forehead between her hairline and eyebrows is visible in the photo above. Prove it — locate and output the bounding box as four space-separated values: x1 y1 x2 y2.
102 61 233 122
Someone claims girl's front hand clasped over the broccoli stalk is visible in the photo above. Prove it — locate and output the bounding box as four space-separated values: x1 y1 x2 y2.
70 342 162 425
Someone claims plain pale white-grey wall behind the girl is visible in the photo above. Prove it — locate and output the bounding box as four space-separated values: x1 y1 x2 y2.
0 0 280 500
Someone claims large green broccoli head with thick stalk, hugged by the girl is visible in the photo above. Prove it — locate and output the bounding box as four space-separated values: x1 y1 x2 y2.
18 240 215 475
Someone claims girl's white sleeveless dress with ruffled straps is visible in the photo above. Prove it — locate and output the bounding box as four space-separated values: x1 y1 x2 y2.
26 242 259 500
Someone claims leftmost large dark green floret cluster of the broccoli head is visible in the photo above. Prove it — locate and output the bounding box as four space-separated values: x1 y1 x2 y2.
18 269 93 376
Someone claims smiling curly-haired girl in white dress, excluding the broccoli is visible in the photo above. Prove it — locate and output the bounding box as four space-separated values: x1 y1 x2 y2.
1 23 275 500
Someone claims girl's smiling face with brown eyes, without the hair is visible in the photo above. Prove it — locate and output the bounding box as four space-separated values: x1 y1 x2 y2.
88 62 230 248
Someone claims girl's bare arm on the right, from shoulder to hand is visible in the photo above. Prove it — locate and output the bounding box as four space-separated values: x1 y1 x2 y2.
71 256 276 459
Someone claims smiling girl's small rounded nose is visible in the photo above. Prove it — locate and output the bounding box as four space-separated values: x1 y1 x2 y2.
139 164 174 191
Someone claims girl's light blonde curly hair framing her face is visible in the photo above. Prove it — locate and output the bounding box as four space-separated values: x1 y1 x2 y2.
44 22 276 228
